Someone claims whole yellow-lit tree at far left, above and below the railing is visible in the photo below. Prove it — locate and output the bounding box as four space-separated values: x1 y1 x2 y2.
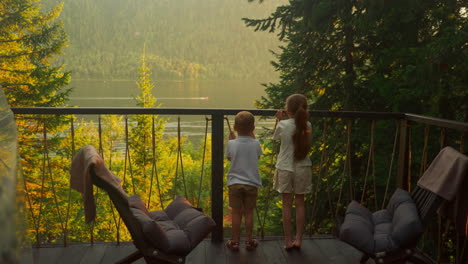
0 0 70 245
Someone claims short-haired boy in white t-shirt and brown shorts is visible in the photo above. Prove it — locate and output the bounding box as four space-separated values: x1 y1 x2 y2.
226 111 262 251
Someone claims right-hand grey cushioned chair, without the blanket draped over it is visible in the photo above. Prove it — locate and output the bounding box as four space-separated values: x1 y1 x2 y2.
339 187 443 263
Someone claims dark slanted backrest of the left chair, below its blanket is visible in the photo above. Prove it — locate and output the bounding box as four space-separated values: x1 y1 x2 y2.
90 168 153 251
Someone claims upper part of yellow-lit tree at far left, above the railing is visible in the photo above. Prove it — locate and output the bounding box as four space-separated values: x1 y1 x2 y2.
0 0 70 107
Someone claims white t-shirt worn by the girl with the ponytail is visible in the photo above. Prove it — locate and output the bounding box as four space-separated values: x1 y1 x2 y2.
273 118 312 172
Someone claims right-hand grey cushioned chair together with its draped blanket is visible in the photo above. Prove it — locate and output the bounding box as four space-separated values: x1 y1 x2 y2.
339 147 468 263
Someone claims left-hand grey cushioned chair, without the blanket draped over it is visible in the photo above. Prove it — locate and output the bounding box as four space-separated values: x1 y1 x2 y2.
90 168 215 263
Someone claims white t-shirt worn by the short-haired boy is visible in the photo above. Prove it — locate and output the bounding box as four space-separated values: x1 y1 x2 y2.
226 136 263 188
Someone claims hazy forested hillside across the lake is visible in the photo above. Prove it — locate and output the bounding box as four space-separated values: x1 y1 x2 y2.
44 0 287 79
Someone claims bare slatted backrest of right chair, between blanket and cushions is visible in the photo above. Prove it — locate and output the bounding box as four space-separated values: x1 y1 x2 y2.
411 186 445 225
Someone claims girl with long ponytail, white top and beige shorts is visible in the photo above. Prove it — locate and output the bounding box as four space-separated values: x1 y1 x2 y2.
273 94 312 250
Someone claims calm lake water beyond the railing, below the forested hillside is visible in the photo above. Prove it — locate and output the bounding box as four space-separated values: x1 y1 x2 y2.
69 80 274 141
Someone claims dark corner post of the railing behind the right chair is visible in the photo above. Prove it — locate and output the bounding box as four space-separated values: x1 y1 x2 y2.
396 119 409 190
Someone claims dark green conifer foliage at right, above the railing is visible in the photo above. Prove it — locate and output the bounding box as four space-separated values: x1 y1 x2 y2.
244 0 468 121
